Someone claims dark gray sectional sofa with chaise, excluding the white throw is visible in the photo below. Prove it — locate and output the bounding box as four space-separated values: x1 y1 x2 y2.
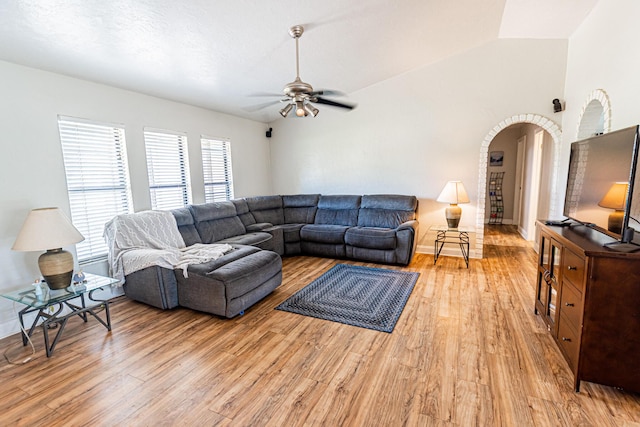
119 194 418 317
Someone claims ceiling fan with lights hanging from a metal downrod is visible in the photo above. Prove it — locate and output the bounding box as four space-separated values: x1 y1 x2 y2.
249 25 356 117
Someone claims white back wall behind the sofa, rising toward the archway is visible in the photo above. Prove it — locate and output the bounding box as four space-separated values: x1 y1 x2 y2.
271 40 567 250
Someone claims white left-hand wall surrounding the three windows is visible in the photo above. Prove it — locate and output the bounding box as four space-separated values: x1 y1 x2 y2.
0 62 271 337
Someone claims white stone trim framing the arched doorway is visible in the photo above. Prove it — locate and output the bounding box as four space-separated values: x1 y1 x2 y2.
475 114 562 258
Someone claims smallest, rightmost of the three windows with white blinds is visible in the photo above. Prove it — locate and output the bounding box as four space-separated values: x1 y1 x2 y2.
200 137 233 203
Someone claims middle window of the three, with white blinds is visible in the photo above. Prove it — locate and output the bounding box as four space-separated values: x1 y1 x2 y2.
144 129 191 210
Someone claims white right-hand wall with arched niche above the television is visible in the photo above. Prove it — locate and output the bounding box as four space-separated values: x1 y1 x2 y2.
555 0 640 212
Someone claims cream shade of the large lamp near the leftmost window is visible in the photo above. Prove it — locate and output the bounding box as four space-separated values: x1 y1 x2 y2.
11 208 84 251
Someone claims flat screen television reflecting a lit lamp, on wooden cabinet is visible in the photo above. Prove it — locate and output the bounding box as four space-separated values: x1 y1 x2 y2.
563 126 640 249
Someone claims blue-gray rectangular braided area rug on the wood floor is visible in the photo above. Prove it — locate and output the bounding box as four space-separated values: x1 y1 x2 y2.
276 264 419 332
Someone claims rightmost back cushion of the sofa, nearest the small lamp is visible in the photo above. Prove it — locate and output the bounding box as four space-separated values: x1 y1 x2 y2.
358 194 418 228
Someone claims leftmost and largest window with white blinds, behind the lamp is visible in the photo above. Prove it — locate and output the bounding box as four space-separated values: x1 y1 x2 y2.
58 117 133 264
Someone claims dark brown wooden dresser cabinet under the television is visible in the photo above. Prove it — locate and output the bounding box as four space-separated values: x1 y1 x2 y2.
535 222 640 392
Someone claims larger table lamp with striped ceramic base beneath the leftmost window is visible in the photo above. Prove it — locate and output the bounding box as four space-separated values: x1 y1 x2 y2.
11 208 84 289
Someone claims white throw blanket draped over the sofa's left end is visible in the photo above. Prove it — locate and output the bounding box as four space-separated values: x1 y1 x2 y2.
104 211 233 285
